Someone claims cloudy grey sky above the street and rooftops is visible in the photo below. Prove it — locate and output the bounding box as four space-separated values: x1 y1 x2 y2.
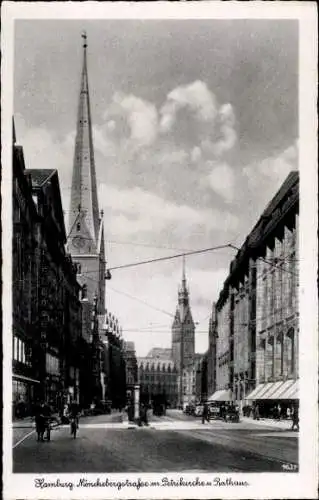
14 20 298 355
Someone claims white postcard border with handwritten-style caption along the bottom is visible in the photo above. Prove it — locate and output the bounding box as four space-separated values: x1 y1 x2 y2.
1 2 318 499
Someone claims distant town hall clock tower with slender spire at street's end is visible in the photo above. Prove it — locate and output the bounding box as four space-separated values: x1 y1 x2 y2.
172 260 195 406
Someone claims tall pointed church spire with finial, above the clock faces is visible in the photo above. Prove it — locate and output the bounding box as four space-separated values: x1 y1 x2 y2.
69 32 99 245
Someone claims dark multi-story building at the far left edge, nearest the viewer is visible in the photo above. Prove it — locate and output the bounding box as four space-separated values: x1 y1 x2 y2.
12 120 41 415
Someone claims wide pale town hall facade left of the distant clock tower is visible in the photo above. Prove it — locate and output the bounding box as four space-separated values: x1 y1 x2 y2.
137 348 178 408
